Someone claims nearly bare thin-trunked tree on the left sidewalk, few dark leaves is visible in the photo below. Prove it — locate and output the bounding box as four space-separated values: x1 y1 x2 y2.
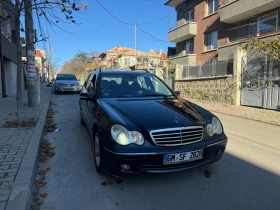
0 0 88 125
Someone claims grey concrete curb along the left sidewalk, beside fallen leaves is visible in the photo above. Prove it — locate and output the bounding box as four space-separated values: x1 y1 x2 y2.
6 92 51 210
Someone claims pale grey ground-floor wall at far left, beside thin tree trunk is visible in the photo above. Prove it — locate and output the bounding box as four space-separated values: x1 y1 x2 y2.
4 61 17 96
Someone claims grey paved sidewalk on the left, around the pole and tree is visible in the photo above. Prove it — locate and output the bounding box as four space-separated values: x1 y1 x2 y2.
0 84 52 210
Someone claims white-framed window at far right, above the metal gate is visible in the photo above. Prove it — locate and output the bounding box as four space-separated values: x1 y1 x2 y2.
259 13 277 35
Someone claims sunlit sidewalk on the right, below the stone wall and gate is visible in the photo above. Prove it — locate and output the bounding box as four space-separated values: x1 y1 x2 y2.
189 98 280 125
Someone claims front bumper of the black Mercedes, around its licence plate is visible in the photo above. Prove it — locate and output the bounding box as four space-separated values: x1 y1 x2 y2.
104 139 227 176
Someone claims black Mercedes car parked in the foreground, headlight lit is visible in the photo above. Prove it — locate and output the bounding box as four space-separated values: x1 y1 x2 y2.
79 70 227 176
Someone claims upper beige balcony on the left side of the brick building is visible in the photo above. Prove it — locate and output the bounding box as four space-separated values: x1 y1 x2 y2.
168 19 197 43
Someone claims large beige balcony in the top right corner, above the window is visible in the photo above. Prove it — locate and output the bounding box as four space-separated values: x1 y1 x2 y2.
220 0 280 23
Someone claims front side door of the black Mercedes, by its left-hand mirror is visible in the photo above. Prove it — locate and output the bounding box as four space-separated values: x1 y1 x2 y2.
86 73 97 135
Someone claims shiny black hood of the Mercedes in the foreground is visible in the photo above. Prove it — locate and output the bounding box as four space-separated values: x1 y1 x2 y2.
100 98 209 130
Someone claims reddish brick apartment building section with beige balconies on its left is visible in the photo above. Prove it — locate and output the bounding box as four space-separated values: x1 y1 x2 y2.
165 0 227 65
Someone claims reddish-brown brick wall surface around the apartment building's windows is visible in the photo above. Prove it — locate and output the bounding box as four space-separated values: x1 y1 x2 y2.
176 0 230 62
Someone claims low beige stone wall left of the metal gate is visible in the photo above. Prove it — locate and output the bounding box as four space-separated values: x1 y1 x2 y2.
175 76 237 104
